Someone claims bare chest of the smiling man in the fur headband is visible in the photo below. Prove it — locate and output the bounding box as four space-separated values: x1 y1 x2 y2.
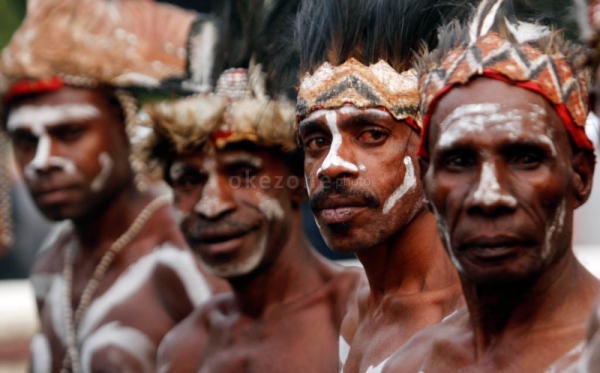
199 307 339 373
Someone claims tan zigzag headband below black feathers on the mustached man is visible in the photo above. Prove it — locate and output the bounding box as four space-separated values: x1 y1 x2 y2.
296 58 421 132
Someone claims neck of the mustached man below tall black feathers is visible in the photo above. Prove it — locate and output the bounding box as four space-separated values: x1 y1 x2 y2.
356 210 458 300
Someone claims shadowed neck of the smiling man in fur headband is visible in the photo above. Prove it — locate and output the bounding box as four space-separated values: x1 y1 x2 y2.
229 211 323 317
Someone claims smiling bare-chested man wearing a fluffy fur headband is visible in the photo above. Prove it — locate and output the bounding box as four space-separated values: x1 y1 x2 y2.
147 0 361 373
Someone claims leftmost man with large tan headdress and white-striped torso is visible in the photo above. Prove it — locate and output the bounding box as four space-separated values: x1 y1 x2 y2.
0 0 225 372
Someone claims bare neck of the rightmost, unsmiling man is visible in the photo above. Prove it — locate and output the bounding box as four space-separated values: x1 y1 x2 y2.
461 248 600 356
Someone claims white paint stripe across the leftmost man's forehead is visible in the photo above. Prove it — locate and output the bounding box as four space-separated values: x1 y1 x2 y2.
7 104 100 131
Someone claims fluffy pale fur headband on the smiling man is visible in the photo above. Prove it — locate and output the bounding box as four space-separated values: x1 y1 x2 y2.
144 65 296 158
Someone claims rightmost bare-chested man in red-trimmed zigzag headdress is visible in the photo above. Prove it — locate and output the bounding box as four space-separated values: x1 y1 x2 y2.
384 0 600 373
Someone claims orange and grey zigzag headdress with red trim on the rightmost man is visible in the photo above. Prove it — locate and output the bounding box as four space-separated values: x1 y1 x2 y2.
419 0 594 157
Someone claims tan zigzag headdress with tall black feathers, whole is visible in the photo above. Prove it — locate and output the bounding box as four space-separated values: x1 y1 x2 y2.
296 0 468 132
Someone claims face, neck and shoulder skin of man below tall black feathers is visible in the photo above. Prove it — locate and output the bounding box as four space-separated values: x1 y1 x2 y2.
299 106 463 372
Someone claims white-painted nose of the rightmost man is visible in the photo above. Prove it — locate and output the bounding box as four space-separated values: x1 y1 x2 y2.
467 162 517 216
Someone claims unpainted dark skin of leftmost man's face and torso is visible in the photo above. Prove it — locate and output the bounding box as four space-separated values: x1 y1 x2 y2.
9 87 227 372
